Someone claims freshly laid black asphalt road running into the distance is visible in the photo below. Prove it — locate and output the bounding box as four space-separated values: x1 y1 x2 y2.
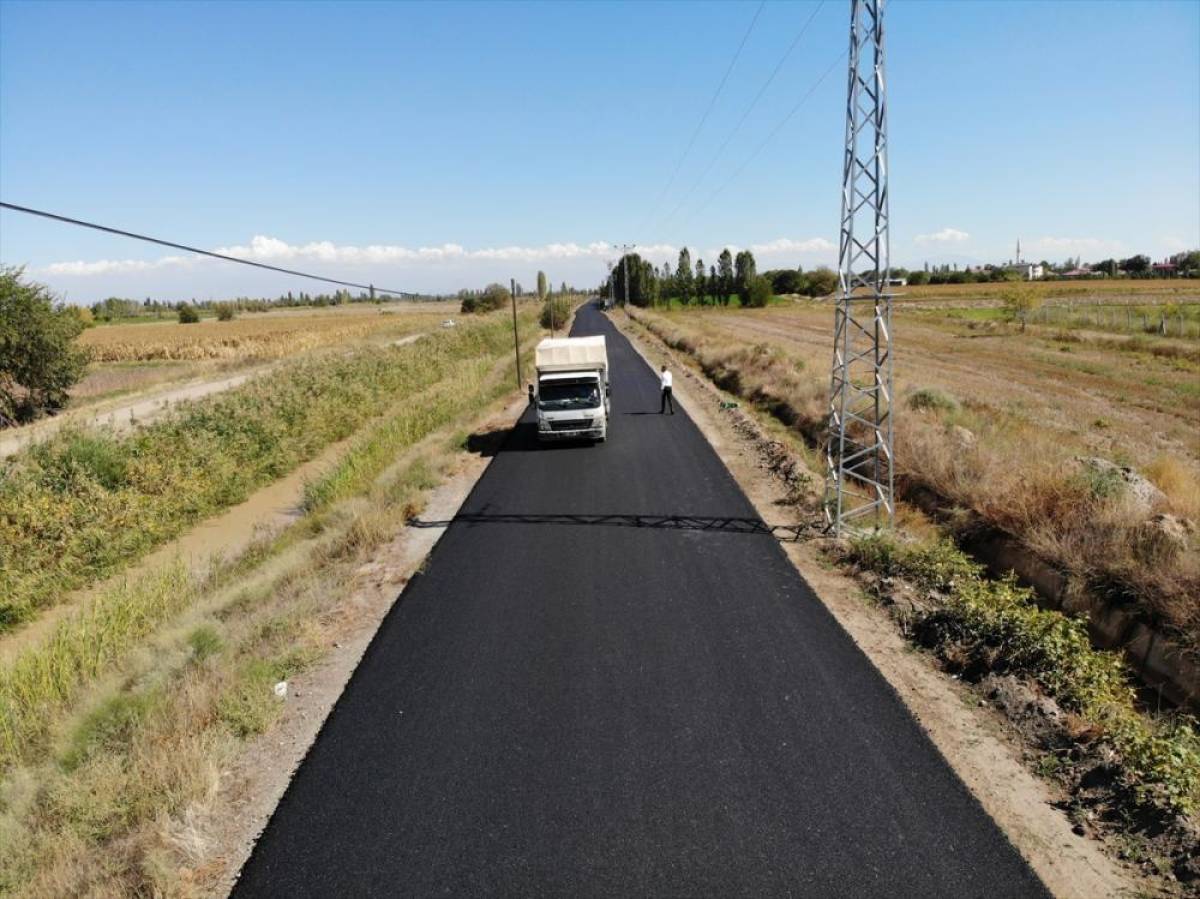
235 308 1045 897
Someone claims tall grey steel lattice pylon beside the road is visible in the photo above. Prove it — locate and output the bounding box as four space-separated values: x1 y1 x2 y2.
824 0 894 534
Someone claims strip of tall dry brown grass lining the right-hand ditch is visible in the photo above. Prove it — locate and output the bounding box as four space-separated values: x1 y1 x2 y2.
629 310 1200 652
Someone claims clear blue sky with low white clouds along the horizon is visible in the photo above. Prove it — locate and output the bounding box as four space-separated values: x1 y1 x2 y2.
0 0 1200 300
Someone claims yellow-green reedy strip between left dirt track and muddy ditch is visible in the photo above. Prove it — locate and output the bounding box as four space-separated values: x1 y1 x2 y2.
0 314 532 631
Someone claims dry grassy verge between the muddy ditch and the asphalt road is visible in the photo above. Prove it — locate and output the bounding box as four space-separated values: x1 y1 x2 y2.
0 313 534 897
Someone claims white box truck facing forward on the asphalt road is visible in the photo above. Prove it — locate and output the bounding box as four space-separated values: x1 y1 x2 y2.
529 336 610 440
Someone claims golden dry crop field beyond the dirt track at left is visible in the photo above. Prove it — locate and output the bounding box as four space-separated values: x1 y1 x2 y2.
79 304 448 362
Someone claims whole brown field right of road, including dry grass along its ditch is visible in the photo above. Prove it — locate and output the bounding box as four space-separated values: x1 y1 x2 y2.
632 301 1200 648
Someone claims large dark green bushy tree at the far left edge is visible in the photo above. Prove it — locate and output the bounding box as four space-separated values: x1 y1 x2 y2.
0 268 88 426
